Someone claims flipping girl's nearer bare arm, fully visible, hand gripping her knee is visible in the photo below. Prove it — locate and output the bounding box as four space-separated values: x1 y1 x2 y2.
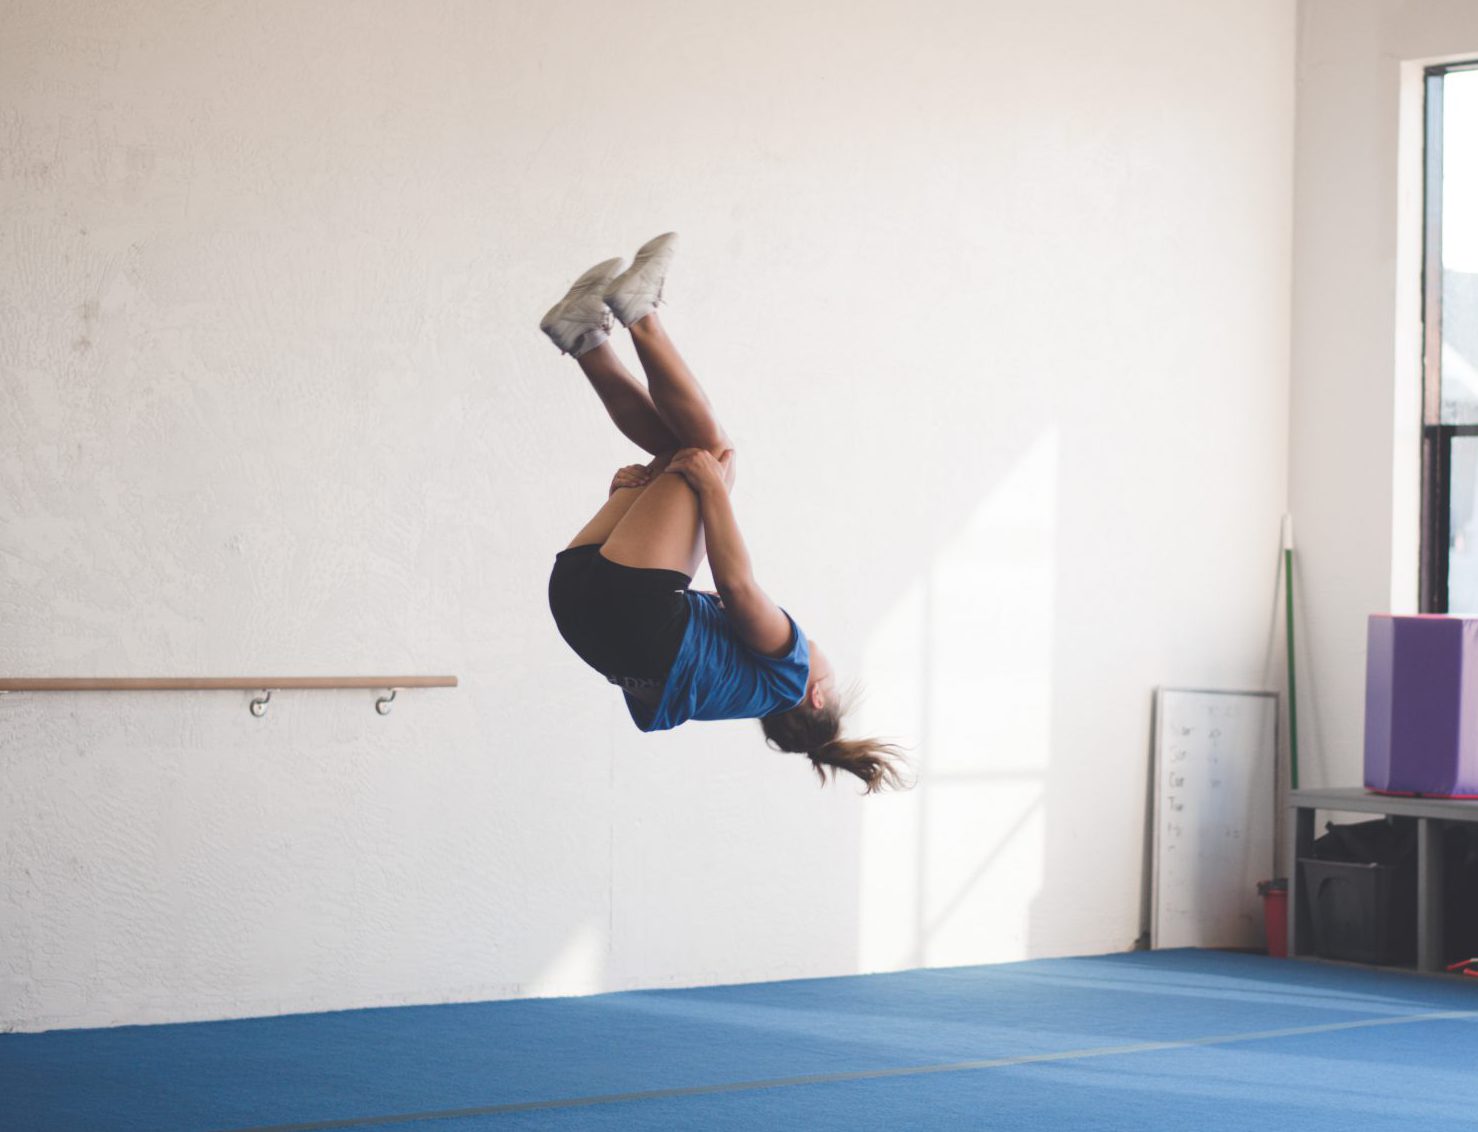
667 448 794 656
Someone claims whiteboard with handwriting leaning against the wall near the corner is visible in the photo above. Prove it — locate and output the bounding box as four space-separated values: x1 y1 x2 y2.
1150 687 1278 949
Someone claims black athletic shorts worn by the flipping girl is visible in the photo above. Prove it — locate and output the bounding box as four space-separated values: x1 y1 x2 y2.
550 544 693 699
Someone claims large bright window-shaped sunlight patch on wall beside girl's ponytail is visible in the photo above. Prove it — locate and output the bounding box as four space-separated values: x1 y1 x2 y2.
857 429 1058 969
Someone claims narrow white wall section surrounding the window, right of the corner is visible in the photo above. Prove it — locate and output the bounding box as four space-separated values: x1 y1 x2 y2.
1289 0 1478 786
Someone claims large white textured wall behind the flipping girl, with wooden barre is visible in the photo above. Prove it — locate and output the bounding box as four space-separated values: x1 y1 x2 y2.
0 0 1295 1029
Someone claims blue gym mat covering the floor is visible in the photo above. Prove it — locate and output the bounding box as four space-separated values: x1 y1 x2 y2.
0 950 1478 1132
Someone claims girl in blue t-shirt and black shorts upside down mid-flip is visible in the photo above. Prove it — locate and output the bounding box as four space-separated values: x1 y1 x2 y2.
539 232 903 794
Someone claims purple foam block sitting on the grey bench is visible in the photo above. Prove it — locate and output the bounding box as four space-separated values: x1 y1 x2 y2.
1366 613 1478 798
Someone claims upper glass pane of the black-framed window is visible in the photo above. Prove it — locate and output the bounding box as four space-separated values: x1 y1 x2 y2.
1443 71 1478 425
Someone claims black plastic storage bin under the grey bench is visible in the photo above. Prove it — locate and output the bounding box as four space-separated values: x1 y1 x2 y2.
1299 857 1416 965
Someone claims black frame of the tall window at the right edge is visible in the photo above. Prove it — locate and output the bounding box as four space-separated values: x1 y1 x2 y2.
1420 59 1478 613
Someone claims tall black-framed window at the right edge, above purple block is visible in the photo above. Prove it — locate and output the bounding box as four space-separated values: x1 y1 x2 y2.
1422 61 1478 613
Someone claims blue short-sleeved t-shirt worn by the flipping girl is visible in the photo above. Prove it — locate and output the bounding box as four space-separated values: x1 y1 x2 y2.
627 590 811 732
